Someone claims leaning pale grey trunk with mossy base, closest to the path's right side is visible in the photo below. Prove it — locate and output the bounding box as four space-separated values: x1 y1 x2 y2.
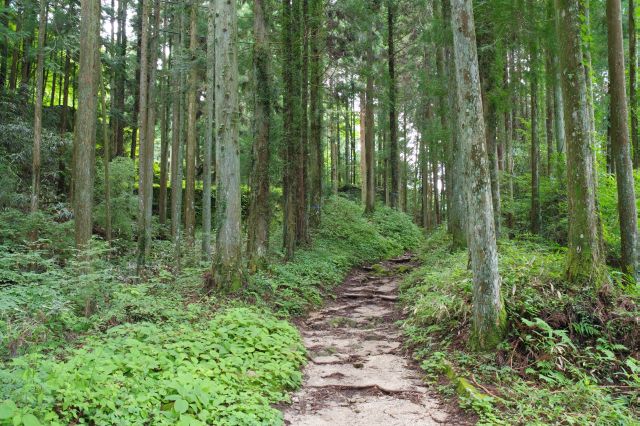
451 0 506 349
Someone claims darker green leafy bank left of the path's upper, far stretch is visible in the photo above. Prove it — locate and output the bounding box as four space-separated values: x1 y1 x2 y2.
246 197 422 315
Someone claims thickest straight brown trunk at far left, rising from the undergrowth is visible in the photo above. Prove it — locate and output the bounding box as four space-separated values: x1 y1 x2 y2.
73 0 100 246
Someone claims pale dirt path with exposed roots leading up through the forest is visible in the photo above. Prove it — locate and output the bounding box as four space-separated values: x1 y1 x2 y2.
284 256 473 426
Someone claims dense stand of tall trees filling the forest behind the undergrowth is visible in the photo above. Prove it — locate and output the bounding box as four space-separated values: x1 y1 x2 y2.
0 0 640 348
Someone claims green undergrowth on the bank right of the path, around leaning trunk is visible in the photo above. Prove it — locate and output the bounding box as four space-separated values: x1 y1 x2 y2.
401 230 640 425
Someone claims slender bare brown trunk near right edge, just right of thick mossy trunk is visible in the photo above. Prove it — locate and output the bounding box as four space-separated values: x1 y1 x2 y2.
607 0 639 280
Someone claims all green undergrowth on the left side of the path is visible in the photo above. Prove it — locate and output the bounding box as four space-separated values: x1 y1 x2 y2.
0 197 423 425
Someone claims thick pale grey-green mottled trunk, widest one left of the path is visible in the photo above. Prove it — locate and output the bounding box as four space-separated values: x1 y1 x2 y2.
213 0 242 291
